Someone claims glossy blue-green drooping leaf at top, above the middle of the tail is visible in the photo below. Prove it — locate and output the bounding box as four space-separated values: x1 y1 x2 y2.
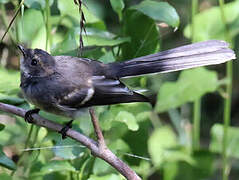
131 0 180 27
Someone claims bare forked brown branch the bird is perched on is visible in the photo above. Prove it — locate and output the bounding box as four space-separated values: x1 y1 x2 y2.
0 103 141 180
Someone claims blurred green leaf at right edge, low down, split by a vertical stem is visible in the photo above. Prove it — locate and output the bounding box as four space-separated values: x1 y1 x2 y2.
210 124 239 158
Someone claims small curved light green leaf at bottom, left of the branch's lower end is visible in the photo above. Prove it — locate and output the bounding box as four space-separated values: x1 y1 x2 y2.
40 160 76 174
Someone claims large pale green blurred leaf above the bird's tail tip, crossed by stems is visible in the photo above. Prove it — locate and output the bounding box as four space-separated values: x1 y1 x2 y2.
184 1 239 41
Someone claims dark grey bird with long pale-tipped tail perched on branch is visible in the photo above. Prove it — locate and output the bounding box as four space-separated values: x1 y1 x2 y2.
18 40 236 138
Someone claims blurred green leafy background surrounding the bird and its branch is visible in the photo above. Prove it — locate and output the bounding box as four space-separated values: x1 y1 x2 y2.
0 0 239 180
